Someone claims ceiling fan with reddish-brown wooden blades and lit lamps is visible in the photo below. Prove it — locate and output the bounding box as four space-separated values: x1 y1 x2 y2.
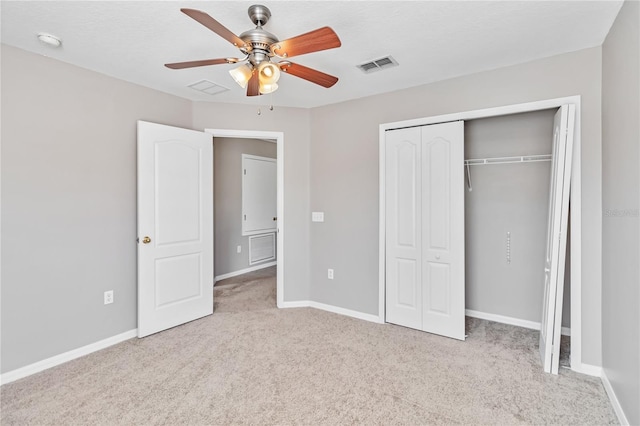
165 4 342 96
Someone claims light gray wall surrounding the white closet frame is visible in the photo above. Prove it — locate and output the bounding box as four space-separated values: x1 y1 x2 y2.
311 47 602 365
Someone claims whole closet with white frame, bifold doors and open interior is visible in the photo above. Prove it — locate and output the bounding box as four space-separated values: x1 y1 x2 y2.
379 96 584 374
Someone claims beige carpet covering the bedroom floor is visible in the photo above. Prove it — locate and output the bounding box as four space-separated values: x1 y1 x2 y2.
0 268 616 425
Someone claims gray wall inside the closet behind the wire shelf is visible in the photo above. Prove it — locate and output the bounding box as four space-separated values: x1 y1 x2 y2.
464 108 571 327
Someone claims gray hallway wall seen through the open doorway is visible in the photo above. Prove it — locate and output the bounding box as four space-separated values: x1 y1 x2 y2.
213 138 277 276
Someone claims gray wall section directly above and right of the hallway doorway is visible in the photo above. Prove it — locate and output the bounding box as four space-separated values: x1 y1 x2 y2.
192 101 311 302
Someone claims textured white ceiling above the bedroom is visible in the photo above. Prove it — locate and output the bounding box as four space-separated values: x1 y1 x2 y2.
0 0 622 108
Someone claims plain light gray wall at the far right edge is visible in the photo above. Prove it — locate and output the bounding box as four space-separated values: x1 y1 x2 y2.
602 1 640 425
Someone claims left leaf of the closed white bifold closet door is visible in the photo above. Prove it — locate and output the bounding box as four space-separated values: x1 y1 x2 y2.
385 128 422 329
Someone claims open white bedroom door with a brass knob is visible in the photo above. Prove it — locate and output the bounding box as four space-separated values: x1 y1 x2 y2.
138 121 214 337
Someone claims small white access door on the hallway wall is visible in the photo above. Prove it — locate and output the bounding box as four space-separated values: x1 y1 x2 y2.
242 154 278 235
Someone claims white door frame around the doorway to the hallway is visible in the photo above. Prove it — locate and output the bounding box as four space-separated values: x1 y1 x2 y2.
204 129 285 308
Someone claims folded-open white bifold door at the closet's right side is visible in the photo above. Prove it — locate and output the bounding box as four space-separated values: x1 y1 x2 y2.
540 105 575 374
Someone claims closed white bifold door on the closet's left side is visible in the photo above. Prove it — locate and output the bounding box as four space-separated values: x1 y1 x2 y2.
385 121 465 340
